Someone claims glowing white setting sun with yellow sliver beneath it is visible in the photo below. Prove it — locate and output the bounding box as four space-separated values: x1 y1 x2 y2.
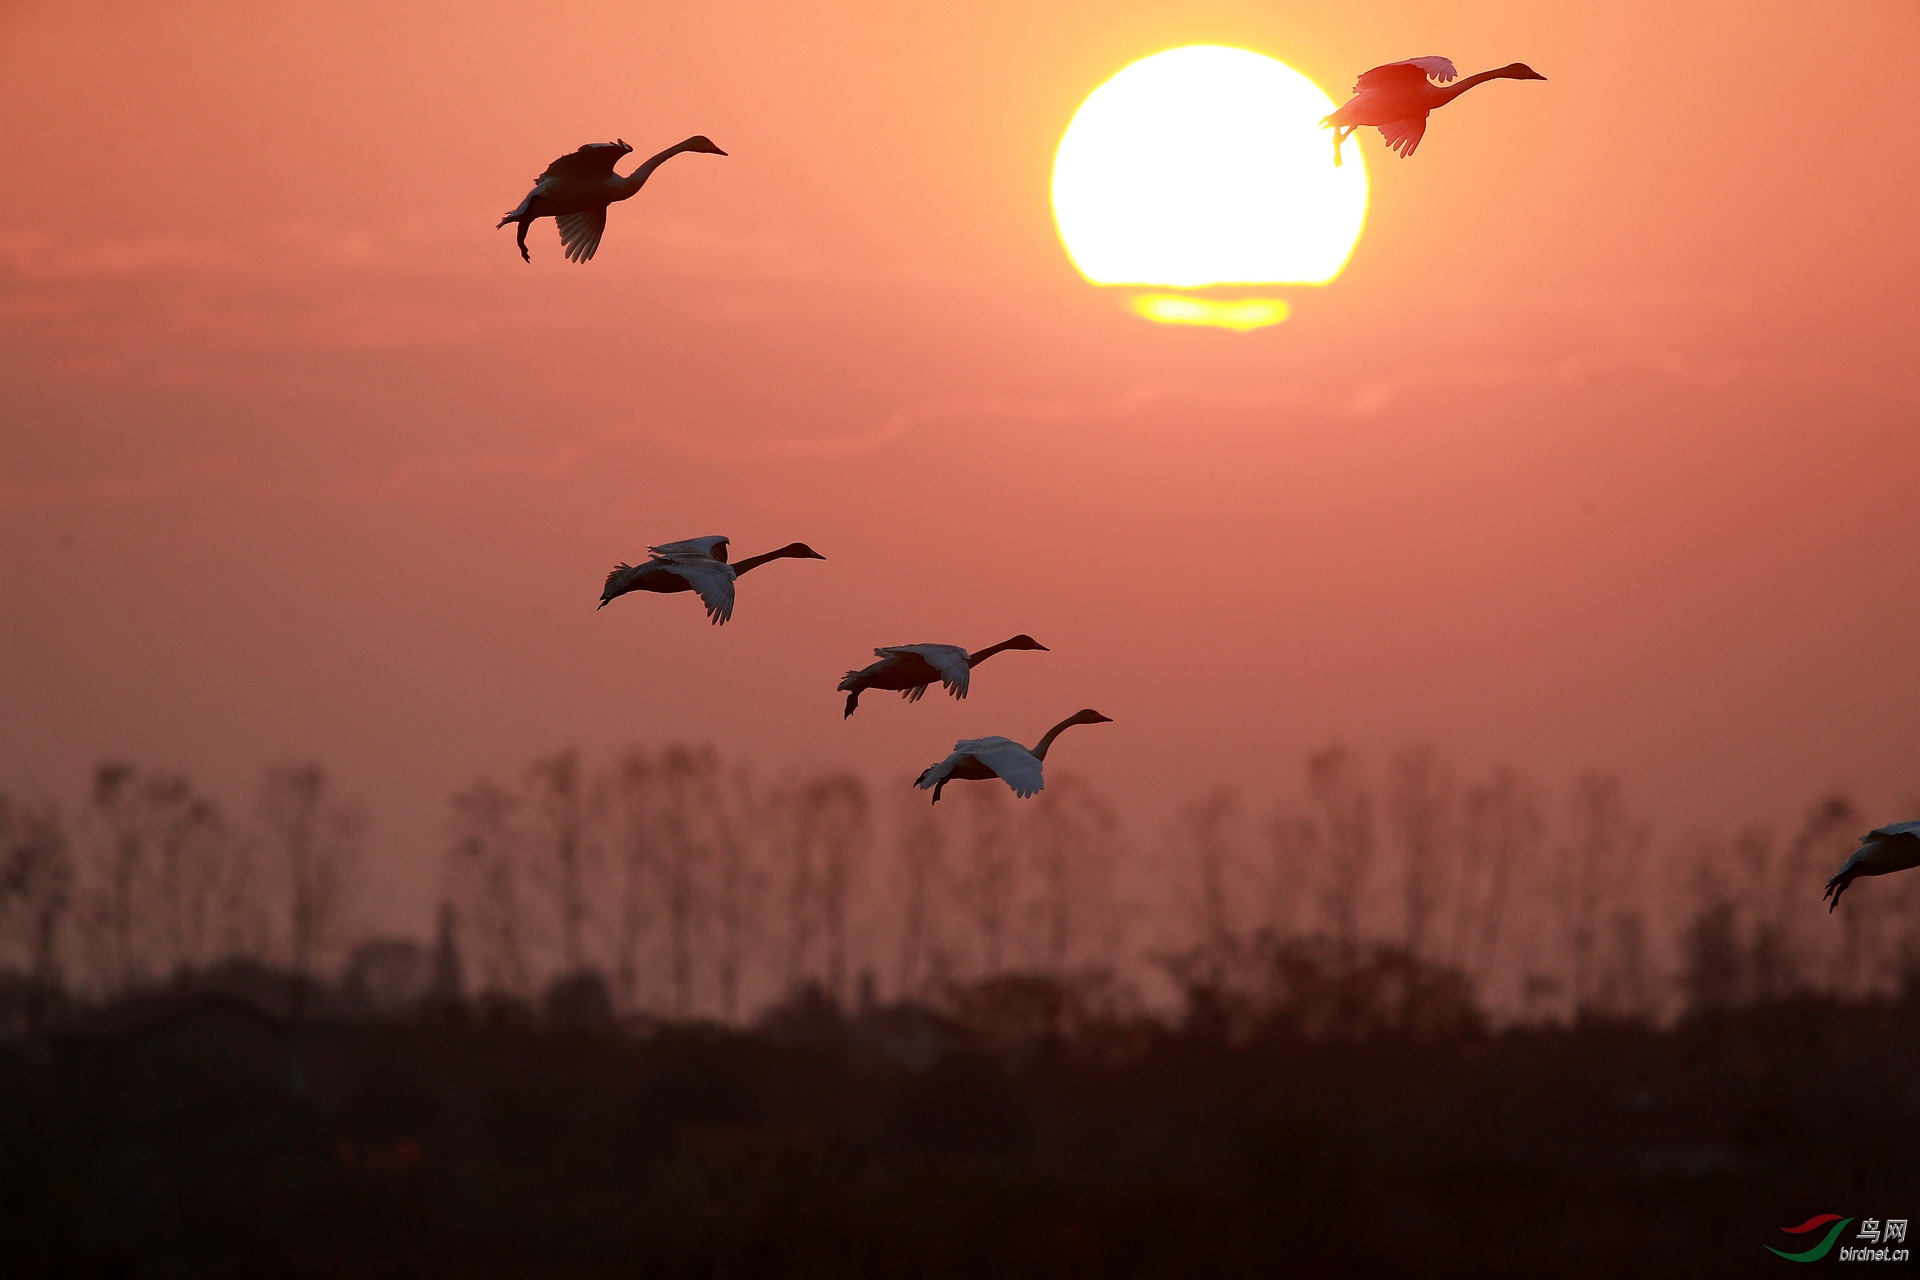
1054 44 1367 328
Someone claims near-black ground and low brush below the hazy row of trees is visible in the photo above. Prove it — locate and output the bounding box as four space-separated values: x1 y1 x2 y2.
0 979 1920 1280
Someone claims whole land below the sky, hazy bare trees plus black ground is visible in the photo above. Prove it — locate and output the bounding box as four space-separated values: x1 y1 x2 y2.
0 745 1920 1276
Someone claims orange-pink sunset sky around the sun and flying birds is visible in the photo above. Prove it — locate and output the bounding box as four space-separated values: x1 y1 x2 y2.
0 0 1920 923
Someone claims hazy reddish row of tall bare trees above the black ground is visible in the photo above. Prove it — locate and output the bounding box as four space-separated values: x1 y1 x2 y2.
0 745 1920 1023
